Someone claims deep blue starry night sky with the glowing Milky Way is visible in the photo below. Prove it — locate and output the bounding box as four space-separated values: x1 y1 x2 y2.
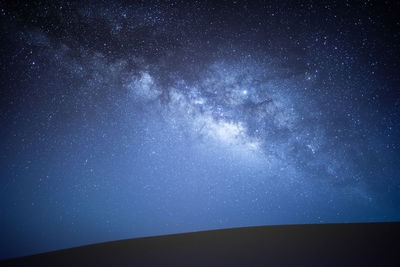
0 0 400 258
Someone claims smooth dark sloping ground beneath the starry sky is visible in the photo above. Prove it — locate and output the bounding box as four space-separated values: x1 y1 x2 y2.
0 223 400 266
